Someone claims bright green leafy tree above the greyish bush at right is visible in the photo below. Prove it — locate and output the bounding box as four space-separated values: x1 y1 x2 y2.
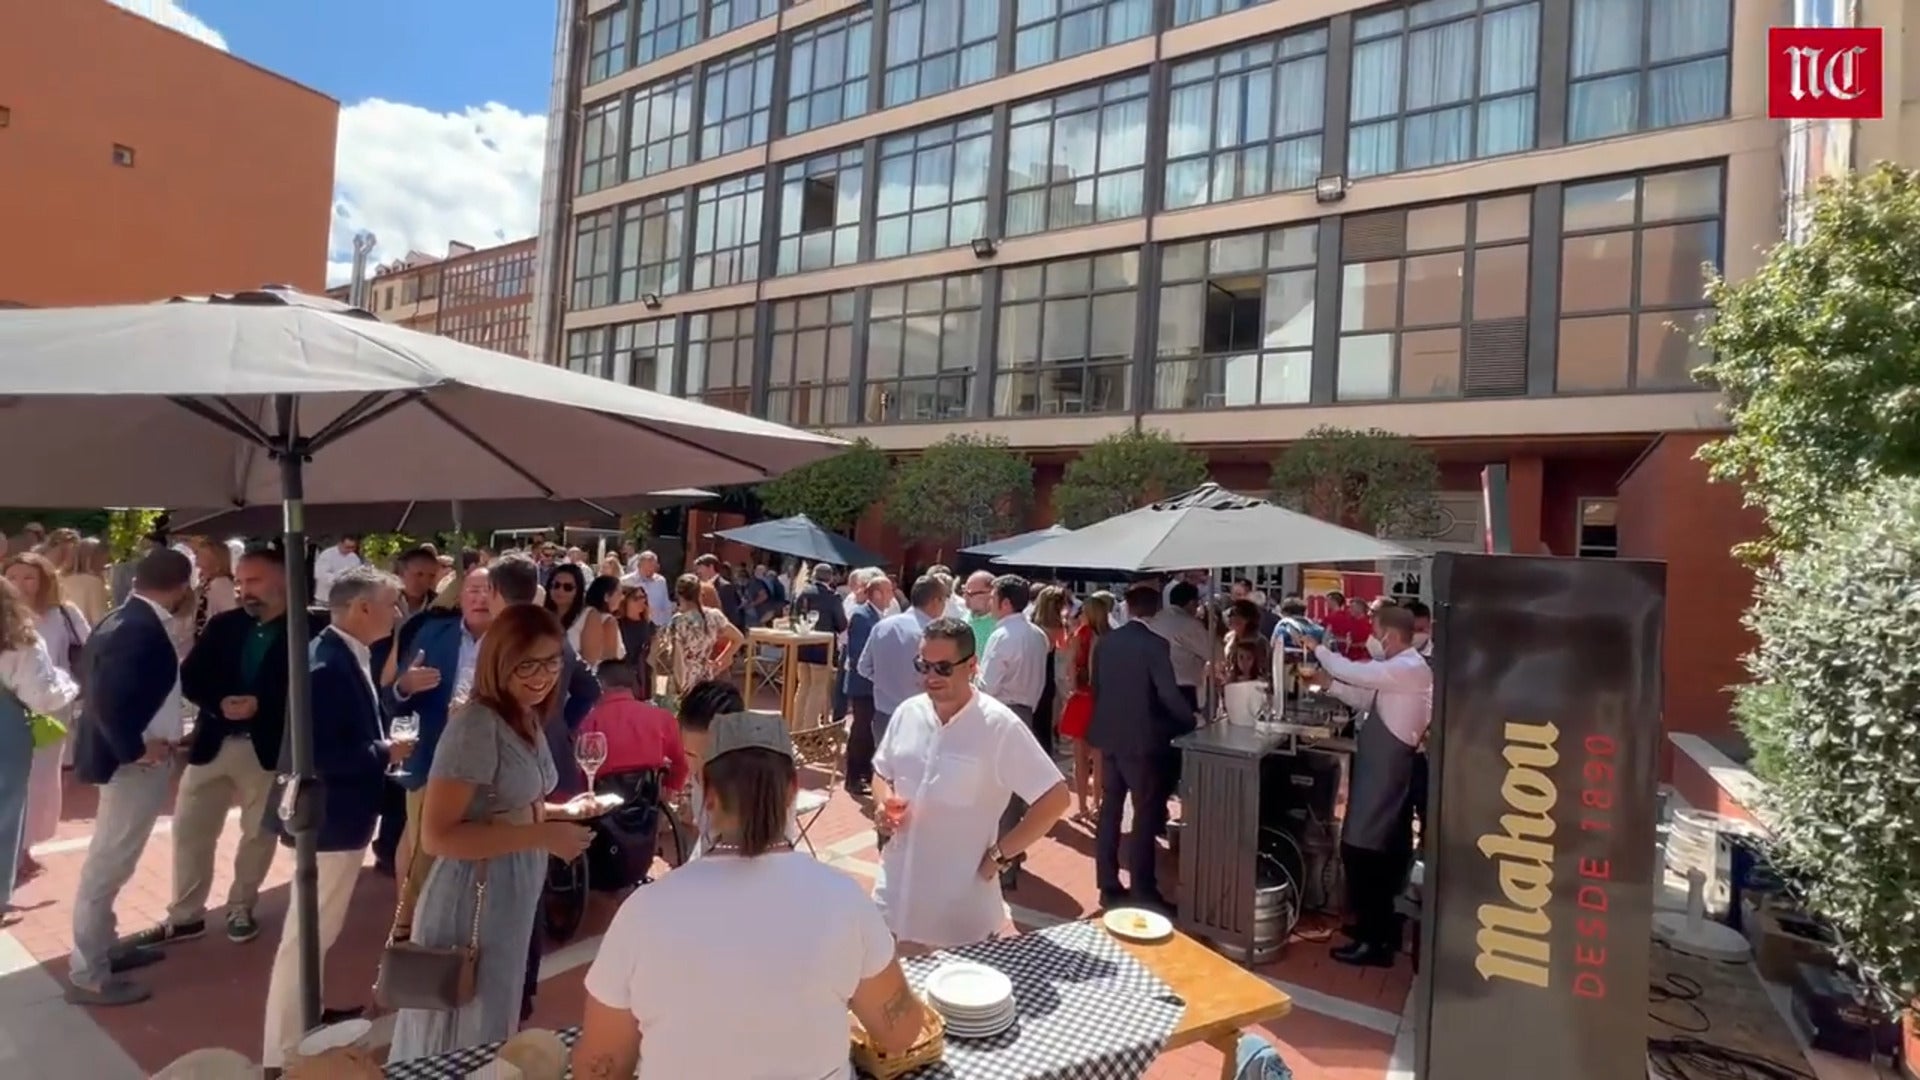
1697 165 1920 563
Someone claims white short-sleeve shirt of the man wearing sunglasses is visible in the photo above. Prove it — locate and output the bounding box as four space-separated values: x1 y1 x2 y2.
871 692 1062 949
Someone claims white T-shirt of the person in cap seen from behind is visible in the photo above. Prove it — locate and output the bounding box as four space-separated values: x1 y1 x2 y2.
586 851 893 1080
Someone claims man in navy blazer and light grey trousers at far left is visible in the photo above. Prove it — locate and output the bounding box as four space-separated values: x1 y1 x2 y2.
67 548 194 1005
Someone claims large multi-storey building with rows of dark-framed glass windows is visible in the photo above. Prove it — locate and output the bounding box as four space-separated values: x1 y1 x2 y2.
536 0 1897 726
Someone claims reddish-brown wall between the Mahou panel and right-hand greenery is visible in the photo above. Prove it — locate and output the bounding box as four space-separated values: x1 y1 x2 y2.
1620 434 1763 753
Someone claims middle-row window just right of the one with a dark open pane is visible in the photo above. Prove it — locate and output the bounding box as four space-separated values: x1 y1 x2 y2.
874 113 993 259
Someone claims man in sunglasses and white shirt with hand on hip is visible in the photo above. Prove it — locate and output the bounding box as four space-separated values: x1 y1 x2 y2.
874 619 1071 951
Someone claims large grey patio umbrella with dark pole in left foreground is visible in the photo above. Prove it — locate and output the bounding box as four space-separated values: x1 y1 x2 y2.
0 288 845 1026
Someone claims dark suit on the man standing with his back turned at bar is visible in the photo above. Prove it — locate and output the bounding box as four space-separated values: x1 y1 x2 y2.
1087 619 1194 901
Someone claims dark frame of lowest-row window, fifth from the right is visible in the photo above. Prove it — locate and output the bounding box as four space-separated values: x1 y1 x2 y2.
858 271 987 427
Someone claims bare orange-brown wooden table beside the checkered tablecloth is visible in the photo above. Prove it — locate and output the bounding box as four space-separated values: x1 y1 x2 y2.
1121 930 1294 1080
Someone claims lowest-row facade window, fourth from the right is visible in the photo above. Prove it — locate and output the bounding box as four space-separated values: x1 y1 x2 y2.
993 252 1140 417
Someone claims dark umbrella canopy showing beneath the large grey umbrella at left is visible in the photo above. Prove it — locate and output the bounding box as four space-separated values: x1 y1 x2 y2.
169 488 718 536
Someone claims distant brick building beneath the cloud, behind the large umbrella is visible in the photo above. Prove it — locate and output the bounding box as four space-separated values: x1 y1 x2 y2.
332 236 534 357
